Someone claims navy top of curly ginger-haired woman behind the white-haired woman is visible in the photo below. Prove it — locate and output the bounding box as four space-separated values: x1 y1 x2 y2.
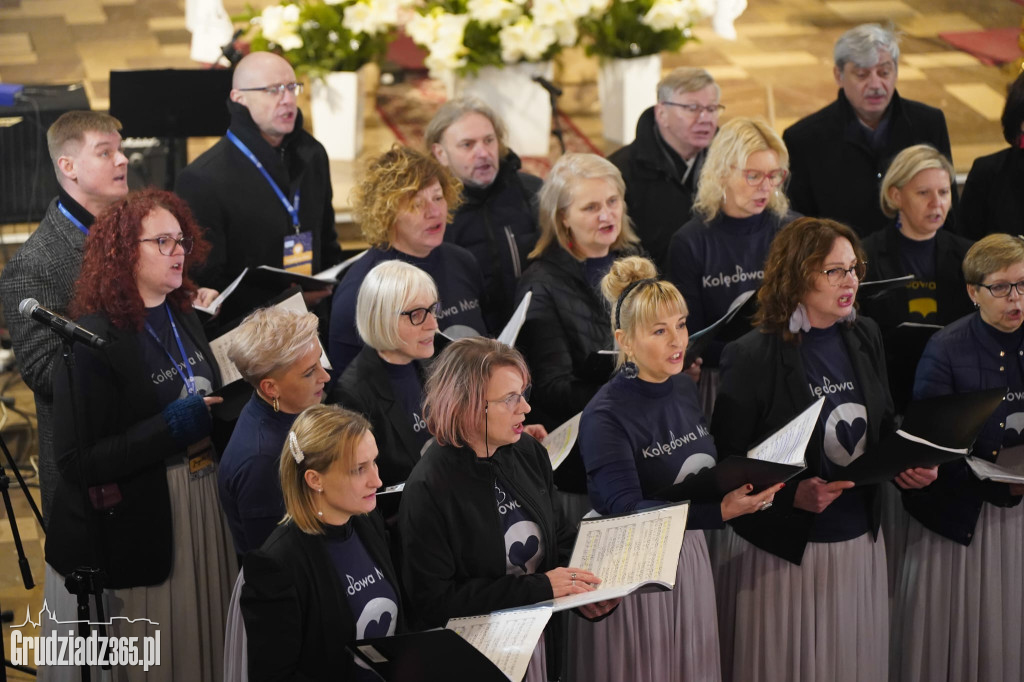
328 242 487 378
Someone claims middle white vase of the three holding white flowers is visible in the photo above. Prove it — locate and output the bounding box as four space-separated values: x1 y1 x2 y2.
455 61 553 157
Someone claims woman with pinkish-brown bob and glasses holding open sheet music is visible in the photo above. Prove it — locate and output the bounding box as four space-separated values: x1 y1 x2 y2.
398 338 617 681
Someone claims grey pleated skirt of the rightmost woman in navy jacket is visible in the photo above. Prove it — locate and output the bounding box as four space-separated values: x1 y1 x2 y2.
890 504 1024 682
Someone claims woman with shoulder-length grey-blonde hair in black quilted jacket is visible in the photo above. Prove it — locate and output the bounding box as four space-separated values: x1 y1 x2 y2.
516 154 638 512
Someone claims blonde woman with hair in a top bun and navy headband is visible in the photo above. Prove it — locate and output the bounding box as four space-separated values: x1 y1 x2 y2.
570 256 782 682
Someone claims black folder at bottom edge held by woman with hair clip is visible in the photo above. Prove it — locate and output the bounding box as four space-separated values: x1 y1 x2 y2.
348 629 509 682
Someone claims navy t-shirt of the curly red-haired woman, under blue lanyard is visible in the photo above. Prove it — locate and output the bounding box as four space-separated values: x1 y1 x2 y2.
139 305 213 406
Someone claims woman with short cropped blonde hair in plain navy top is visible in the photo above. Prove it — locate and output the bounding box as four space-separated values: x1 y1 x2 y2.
217 307 331 555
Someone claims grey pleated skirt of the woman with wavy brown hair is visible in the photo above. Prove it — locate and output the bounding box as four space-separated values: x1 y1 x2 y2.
717 532 889 682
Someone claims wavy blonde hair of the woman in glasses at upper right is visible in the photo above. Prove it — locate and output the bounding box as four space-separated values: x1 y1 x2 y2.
693 116 790 222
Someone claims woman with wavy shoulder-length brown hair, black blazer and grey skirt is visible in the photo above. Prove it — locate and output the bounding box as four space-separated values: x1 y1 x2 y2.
712 218 935 682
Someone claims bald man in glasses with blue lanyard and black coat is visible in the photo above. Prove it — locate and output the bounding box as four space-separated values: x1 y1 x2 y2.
175 52 341 288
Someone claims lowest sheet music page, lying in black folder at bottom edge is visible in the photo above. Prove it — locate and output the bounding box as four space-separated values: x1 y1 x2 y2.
444 606 552 682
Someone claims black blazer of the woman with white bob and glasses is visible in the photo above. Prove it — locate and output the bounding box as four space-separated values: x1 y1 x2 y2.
333 346 422 485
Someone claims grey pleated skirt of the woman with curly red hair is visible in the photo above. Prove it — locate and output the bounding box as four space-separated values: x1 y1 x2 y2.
40 461 238 682
